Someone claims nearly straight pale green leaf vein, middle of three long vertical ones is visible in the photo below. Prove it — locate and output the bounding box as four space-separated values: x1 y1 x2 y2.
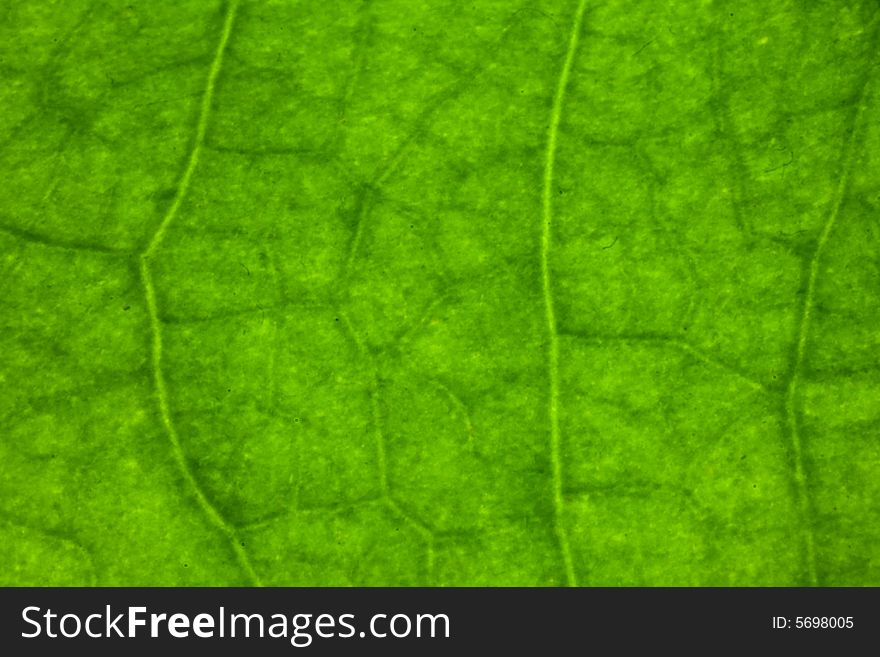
541 0 587 586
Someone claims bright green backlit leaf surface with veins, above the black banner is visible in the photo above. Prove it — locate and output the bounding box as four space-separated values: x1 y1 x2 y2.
0 0 880 586
